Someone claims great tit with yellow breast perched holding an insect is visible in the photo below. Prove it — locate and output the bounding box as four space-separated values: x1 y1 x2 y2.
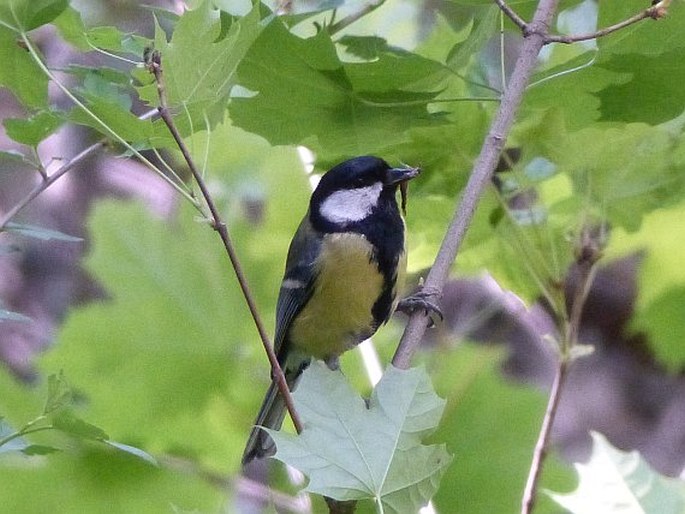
242 156 420 465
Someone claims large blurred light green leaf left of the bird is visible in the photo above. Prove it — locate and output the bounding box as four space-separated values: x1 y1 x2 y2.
42 195 288 469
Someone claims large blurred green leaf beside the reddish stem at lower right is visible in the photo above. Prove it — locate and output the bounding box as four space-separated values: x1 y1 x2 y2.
428 344 575 514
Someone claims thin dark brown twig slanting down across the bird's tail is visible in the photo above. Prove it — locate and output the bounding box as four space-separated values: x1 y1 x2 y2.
149 51 302 433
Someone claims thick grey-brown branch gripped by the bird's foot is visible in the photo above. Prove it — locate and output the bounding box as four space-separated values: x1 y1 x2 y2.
392 0 559 369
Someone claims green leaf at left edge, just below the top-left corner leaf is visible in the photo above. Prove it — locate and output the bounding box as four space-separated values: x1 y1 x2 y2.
0 27 48 109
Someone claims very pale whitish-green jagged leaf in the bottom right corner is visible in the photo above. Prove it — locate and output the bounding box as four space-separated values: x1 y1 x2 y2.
550 432 685 514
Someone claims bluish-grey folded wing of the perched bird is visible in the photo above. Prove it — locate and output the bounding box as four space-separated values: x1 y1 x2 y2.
274 213 322 366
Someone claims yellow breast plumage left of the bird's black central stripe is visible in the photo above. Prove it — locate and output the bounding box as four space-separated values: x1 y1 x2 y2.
290 233 383 359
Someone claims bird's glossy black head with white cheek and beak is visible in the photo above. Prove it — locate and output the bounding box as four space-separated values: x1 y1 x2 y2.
310 156 420 230
